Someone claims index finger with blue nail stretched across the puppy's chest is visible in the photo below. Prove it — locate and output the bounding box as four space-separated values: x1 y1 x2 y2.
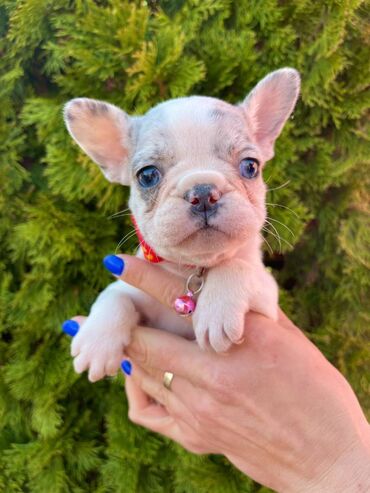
104 255 185 309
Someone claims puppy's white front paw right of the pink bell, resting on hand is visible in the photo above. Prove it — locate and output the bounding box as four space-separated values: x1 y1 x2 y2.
193 293 249 352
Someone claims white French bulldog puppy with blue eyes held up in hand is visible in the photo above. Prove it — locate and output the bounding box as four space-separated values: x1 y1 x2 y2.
64 68 300 381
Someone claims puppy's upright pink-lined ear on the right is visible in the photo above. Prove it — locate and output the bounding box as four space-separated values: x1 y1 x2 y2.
241 68 300 161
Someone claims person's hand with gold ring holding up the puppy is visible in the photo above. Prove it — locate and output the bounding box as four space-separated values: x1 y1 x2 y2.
65 256 370 493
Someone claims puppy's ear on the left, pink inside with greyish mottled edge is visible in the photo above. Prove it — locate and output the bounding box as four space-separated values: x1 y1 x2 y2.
64 98 130 185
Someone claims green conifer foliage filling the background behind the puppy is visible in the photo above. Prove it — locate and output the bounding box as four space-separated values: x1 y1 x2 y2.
0 0 370 493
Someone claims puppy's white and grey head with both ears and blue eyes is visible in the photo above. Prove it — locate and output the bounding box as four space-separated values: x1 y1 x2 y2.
64 68 300 266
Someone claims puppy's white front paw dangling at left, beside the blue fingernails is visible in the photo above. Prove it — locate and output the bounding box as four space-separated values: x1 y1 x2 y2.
71 314 131 382
